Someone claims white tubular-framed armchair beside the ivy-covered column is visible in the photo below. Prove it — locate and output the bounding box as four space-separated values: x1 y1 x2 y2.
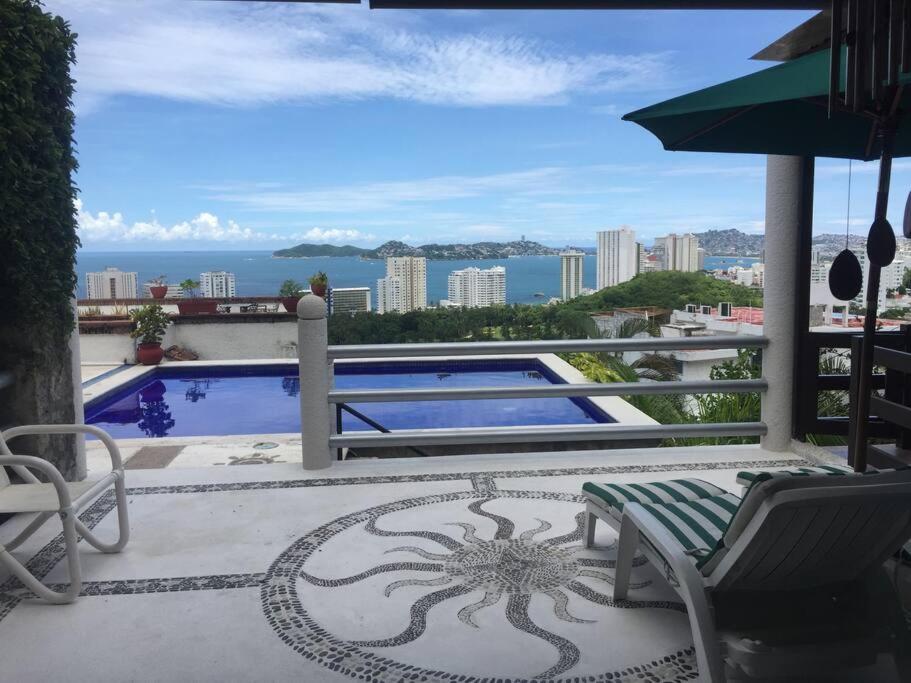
0 425 130 604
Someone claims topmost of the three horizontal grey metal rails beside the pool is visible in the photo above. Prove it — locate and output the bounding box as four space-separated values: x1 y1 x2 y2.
327 335 769 360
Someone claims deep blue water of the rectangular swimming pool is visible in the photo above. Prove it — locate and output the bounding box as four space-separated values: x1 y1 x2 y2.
86 359 614 438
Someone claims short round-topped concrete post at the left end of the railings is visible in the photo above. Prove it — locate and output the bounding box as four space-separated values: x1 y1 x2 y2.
297 294 332 470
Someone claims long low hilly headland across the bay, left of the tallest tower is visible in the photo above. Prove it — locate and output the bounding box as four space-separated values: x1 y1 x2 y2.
272 240 560 261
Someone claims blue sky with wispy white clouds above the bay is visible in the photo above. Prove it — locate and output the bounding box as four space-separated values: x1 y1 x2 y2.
45 0 911 251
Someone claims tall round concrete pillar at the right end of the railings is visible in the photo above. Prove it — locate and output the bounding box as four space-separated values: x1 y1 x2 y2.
761 156 813 451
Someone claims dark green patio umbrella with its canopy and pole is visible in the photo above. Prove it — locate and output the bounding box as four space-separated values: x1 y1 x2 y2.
623 50 911 470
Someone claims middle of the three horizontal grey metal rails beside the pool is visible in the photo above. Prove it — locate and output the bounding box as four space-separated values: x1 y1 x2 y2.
329 379 769 404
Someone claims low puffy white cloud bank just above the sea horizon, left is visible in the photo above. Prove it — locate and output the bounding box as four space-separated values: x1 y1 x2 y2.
76 199 376 245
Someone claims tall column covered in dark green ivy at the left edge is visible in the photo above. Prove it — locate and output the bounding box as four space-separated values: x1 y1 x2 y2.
0 0 79 478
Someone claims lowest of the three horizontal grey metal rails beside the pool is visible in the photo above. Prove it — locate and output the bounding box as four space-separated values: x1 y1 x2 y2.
329 422 767 448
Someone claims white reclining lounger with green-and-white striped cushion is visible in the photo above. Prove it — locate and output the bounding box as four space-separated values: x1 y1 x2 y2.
584 467 911 681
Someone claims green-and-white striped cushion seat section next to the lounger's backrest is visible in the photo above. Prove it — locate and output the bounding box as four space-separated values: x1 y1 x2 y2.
642 493 740 567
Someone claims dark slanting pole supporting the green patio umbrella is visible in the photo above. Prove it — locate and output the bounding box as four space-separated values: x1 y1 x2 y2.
853 122 895 472
